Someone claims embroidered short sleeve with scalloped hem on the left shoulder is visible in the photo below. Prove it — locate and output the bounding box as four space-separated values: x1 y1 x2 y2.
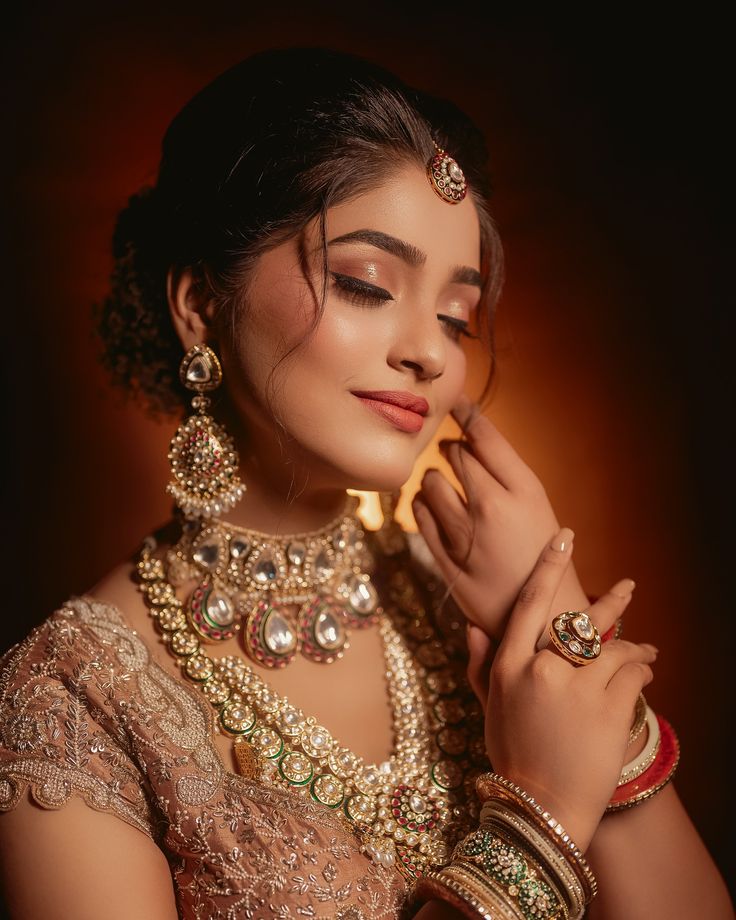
0 609 159 840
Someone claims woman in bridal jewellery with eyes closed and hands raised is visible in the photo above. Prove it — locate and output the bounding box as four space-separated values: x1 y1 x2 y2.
0 50 730 920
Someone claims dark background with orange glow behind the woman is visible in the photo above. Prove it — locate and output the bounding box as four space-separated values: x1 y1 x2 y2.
0 2 735 904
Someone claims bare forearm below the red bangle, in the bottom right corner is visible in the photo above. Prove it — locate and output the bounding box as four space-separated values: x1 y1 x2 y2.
586 784 733 920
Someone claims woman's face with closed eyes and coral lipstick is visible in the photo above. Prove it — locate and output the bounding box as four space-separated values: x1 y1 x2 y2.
221 166 480 491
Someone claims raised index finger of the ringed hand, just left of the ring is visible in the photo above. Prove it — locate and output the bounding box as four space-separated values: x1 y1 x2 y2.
499 527 575 659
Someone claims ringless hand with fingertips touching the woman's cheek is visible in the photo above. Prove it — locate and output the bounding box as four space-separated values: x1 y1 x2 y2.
412 396 588 641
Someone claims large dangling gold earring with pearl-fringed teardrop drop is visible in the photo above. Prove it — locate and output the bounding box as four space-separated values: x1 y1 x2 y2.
166 345 245 518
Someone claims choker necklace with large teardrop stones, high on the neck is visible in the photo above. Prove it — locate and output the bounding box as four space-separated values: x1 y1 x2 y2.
164 496 381 668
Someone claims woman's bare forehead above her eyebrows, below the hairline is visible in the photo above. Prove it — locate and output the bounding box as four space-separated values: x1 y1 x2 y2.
327 166 480 269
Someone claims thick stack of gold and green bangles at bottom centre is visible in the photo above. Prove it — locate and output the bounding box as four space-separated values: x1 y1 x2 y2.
417 773 597 920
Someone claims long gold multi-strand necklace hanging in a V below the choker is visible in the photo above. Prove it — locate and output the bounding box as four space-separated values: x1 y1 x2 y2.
137 532 488 878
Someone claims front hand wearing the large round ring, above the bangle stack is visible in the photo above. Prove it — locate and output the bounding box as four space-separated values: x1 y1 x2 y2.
475 528 657 849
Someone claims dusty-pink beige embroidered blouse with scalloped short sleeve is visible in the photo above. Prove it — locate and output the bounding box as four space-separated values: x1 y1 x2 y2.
0 598 414 920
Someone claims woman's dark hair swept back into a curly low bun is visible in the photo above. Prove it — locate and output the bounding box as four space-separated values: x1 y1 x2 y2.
99 48 502 414
